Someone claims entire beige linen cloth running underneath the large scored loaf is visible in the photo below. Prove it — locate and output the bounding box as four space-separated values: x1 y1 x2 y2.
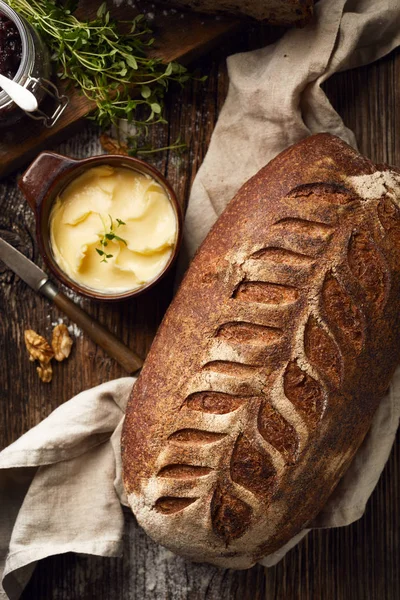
0 0 400 600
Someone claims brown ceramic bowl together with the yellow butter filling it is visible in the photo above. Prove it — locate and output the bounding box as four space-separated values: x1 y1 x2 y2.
19 152 182 301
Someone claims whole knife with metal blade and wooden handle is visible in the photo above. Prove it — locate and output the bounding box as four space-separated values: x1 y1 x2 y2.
0 238 143 373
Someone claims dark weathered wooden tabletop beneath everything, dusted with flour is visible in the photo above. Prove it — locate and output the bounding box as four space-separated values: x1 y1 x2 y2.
0 21 400 600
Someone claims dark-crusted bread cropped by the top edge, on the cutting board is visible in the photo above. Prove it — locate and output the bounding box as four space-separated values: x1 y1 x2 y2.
158 0 314 25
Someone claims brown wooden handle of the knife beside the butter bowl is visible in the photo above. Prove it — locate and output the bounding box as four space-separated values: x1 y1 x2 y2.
40 281 143 374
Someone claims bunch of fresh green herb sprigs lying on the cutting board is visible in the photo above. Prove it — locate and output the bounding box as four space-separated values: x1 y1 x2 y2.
6 0 190 128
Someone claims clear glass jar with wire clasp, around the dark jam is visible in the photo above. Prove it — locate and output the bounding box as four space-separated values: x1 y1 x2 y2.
0 0 68 127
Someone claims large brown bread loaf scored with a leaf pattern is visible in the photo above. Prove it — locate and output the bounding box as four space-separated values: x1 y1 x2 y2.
122 134 400 568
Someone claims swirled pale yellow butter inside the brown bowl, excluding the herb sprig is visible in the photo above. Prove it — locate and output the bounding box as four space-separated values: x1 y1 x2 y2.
50 166 177 293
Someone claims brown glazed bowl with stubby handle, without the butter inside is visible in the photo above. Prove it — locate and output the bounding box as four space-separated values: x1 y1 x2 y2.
18 152 183 301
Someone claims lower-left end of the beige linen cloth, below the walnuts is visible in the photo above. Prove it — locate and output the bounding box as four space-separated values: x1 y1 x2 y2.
0 377 131 599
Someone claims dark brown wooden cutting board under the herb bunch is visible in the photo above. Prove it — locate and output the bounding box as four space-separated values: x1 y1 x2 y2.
0 0 240 178
